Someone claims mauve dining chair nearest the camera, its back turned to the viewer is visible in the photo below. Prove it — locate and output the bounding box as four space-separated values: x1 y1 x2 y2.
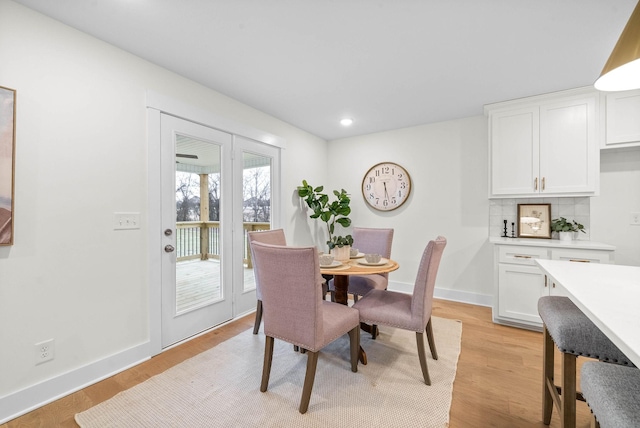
252 241 360 413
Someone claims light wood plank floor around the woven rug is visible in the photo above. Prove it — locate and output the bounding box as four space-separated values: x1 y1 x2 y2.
0 300 589 428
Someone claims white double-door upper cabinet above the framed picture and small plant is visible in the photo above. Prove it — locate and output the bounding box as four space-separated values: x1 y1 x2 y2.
485 89 600 198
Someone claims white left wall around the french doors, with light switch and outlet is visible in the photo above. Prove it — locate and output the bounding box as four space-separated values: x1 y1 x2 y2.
0 0 327 423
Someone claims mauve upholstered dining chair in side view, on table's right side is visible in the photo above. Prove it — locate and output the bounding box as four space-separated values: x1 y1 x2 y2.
353 236 447 385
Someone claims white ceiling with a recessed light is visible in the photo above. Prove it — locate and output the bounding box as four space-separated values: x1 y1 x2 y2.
15 0 636 140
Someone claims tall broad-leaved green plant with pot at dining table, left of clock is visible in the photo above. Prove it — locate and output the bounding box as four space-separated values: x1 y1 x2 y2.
297 180 353 260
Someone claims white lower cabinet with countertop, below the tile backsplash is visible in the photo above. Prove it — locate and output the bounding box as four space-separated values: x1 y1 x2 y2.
490 238 615 330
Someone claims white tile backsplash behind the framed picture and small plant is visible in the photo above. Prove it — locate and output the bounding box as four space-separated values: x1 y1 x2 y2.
489 197 591 241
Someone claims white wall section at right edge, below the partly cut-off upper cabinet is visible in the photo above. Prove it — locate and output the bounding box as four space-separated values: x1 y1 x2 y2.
591 147 640 266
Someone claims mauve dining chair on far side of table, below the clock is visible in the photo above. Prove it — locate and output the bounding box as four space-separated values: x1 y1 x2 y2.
329 227 393 301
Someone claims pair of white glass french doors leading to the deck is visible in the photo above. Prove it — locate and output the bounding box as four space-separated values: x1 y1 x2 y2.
154 114 280 348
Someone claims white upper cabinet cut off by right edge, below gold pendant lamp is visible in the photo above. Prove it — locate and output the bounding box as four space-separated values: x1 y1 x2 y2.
602 90 640 148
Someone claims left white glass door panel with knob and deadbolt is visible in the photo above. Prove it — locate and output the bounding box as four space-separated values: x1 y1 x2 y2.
160 114 233 348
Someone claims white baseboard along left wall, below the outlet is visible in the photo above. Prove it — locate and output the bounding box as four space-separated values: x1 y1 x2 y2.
0 342 150 424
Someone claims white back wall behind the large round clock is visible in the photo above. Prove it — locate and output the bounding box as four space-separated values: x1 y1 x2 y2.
328 116 493 305
